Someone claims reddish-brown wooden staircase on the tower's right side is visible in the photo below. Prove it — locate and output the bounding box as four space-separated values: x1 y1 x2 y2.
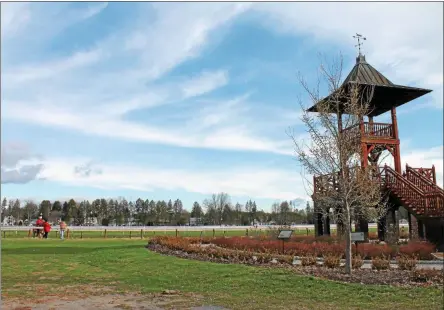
380 165 444 218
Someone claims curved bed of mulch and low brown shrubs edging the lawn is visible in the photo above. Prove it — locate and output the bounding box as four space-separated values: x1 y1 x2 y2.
147 237 444 286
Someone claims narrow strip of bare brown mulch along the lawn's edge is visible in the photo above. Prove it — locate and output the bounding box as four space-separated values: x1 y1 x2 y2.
147 243 444 288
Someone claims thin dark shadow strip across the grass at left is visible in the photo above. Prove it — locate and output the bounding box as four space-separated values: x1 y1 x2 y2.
2 244 145 255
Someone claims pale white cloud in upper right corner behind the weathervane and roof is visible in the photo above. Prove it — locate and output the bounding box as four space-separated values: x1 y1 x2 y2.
254 2 443 108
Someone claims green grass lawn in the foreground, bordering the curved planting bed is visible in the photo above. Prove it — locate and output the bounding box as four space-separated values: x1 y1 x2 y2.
1 239 443 309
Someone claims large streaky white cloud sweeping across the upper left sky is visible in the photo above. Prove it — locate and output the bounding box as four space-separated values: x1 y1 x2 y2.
2 3 294 153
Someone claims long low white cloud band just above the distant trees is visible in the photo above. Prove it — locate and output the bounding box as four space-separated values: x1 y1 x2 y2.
36 158 306 200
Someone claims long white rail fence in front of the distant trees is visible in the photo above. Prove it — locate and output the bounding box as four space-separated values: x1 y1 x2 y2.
0 223 409 231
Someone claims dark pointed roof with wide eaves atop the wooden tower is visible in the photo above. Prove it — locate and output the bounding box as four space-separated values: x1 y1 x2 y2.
308 54 431 116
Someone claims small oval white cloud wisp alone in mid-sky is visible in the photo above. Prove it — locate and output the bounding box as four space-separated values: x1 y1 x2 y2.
182 70 228 97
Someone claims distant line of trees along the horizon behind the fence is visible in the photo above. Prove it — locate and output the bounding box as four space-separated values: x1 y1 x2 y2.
1 193 313 226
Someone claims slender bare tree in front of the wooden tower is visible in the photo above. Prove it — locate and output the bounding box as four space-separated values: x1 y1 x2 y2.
288 56 387 273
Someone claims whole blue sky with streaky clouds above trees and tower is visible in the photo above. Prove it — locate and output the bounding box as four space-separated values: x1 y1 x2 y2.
1 2 443 210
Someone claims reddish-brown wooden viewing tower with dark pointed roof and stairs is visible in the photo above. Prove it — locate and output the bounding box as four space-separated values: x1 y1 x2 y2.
308 53 444 246
